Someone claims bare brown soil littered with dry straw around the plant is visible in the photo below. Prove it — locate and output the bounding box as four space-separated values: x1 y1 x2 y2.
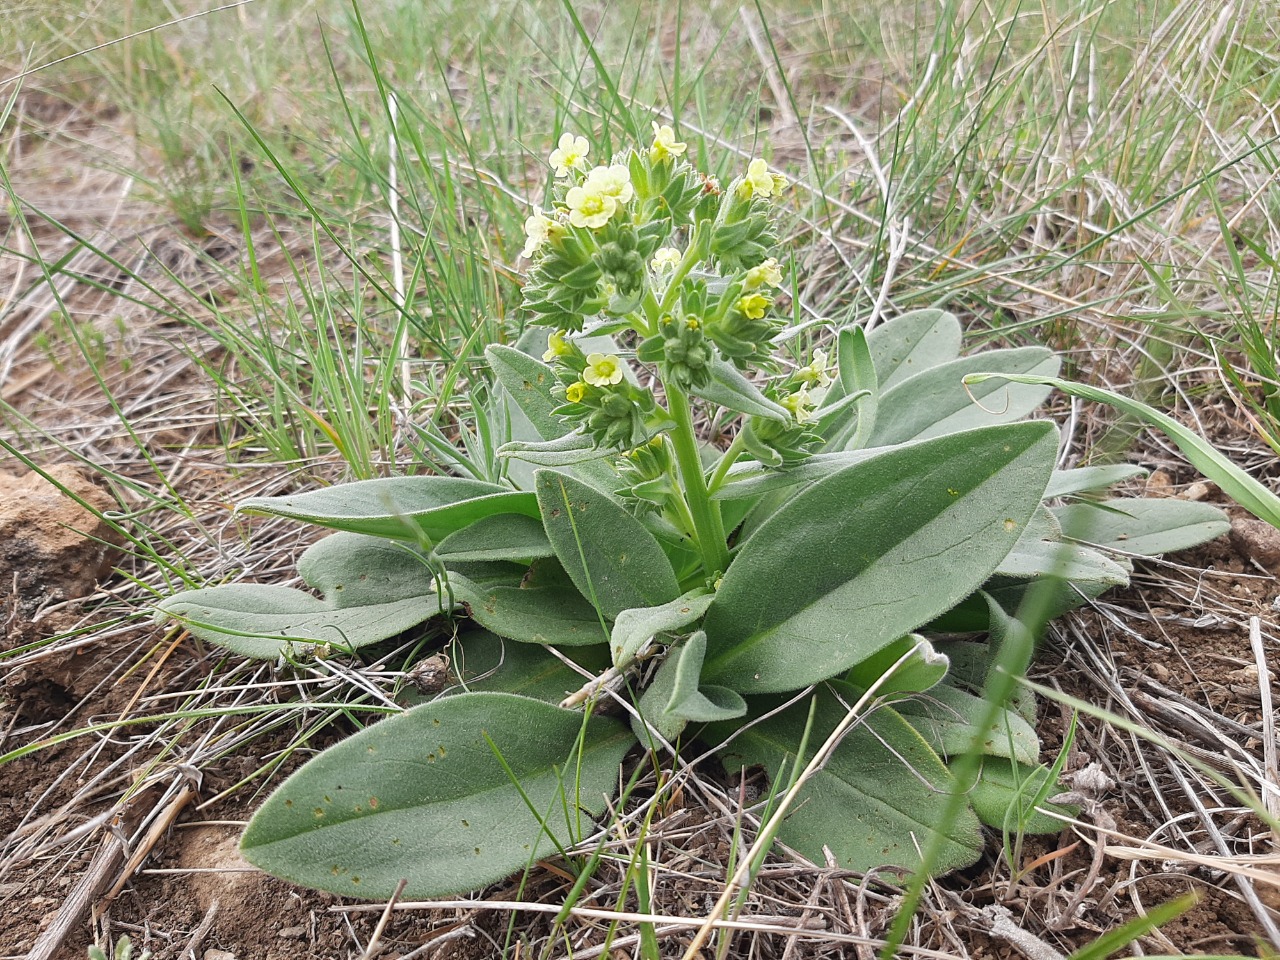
0 97 1280 960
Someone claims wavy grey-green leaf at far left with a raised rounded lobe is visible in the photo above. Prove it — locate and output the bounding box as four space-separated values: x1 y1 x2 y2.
159 534 449 660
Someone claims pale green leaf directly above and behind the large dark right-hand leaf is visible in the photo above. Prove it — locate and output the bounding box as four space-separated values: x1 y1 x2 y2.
869 347 1060 447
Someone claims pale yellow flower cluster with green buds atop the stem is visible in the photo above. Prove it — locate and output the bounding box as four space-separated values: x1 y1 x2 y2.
524 123 829 488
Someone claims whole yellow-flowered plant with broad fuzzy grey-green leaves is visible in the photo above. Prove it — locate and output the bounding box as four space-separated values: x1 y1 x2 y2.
161 124 1226 897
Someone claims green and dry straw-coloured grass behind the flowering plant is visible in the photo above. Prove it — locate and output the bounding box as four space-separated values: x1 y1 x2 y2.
0 0 1280 955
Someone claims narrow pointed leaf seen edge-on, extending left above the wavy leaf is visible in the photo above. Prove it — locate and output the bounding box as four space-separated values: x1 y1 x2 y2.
237 476 539 541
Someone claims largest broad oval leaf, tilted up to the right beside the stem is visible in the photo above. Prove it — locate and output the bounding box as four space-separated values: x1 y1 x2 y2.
703 421 1057 692
